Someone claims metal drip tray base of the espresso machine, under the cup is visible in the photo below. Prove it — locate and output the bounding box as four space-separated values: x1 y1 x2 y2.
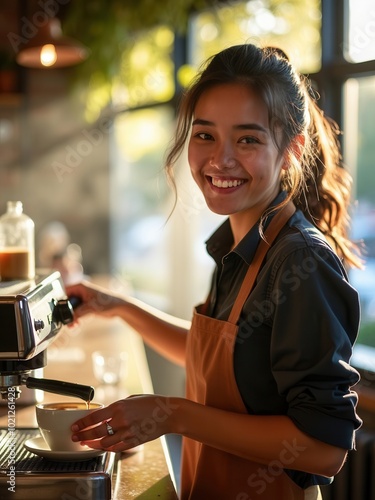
0 429 115 500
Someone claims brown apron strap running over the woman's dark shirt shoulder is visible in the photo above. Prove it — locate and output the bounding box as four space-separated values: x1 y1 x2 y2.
228 201 296 325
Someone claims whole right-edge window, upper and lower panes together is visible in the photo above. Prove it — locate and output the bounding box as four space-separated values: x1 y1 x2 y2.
343 0 375 352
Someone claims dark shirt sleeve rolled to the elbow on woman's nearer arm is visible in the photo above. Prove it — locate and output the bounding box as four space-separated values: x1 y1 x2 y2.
271 247 361 449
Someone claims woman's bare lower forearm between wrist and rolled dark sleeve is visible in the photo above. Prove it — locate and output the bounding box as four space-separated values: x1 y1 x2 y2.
169 398 347 477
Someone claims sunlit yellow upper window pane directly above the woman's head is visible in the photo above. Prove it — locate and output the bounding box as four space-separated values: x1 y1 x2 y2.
190 0 324 74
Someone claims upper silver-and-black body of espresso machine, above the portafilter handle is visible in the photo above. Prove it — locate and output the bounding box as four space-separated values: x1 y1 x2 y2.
0 271 73 399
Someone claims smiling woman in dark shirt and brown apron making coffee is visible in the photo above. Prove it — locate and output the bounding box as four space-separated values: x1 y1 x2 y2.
67 44 361 500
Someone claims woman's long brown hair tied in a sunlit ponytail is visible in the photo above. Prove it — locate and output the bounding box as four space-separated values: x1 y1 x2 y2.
166 44 362 267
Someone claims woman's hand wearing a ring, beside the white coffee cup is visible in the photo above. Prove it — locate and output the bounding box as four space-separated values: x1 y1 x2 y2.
72 394 179 452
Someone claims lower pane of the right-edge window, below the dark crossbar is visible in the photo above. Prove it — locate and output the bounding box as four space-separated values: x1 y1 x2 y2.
344 76 375 347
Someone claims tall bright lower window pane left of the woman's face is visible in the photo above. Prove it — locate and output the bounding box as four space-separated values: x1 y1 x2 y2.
110 106 173 309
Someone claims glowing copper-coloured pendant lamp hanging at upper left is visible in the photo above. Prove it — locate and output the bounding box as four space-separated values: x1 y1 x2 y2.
16 17 88 68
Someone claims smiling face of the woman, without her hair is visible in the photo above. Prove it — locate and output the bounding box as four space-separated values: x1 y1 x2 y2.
188 84 286 234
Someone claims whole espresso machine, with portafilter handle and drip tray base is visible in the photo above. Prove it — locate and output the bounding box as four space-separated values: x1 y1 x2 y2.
0 271 114 500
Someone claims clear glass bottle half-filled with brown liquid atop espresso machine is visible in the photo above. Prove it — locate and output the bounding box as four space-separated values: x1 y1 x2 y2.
0 201 35 281
